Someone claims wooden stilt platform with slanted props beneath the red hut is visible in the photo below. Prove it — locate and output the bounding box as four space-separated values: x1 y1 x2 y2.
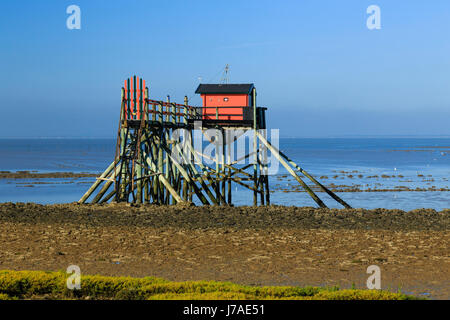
78 76 350 208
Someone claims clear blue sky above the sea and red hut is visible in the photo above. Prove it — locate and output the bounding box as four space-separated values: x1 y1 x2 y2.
0 0 450 137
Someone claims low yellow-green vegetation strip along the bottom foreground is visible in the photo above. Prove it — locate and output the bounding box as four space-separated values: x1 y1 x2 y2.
0 271 414 300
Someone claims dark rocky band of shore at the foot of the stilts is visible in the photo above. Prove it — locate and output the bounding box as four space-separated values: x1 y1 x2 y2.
0 203 450 231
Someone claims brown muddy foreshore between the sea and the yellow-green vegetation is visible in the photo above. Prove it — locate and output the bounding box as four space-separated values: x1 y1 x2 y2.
0 203 450 299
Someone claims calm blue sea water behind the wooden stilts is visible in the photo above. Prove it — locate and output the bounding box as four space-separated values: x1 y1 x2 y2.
0 138 450 210
